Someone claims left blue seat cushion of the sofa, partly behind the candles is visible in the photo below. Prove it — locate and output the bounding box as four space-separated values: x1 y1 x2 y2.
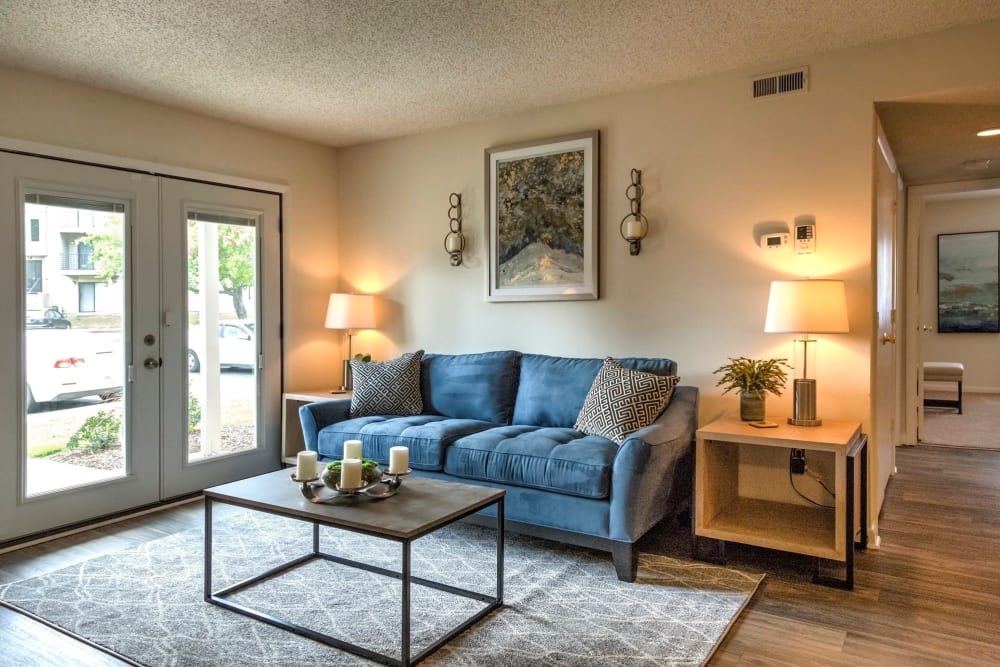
317 415 496 470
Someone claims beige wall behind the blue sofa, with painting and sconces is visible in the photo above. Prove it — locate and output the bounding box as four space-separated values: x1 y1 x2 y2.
337 23 1000 430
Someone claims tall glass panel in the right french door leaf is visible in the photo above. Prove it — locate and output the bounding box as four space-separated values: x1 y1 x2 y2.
187 211 259 461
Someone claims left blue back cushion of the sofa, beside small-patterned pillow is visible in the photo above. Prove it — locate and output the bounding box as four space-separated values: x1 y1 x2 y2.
420 350 521 424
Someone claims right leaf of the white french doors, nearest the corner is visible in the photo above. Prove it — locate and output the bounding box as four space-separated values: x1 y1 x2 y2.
161 179 281 498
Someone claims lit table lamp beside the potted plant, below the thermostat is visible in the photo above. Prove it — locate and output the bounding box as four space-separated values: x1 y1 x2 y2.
764 280 848 426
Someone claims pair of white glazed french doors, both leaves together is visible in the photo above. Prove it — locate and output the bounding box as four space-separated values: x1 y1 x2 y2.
0 152 280 543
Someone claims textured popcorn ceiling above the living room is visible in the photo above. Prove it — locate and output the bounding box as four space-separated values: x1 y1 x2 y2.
0 0 1000 183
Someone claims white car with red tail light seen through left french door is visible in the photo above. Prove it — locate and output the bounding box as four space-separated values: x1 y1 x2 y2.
25 329 124 412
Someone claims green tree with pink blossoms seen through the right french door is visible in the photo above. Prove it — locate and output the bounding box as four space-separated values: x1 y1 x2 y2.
188 220 257 319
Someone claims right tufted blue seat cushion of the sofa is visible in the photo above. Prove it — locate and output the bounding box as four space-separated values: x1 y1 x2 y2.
444 425 618 498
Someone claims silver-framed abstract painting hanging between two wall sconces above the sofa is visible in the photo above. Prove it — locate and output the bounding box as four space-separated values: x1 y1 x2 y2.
485 131 600 301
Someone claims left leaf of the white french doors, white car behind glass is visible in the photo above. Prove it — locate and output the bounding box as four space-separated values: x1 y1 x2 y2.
0 153 161 542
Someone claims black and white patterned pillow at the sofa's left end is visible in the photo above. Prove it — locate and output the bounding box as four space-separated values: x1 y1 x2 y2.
351 350 424 417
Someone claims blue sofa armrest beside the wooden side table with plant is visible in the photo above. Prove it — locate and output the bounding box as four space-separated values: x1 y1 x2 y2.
609 386 698 542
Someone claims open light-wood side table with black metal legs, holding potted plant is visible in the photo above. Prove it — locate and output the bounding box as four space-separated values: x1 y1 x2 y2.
695 418 868 590
